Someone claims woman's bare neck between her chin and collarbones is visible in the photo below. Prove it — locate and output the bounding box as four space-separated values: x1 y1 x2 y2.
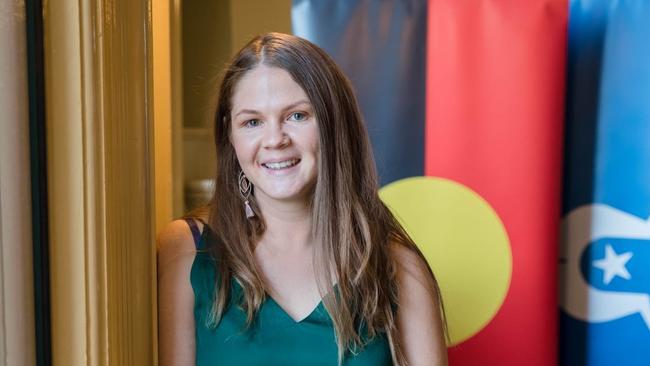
256 197 312 252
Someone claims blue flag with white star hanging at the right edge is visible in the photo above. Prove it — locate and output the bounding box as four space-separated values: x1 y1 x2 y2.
560 0 650 366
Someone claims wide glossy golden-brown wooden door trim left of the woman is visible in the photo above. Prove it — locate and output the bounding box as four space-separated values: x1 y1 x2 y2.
44 0 156 365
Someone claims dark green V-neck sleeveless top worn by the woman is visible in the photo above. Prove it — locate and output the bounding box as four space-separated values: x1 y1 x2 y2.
188 220 392 366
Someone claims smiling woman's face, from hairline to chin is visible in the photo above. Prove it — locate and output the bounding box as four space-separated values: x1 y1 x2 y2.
230 65 319 206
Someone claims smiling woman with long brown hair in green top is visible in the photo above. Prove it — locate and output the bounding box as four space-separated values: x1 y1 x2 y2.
158 33 447 366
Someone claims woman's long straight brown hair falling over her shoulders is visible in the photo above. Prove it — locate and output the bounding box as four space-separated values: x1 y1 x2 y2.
208 33 441 365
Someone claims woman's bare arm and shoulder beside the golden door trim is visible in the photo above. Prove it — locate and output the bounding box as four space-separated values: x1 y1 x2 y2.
157 220 196 366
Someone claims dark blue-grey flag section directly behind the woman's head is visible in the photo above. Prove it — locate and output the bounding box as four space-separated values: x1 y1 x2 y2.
291 0 427 185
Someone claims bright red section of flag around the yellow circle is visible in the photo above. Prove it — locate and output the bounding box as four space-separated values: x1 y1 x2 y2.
425 0 568 366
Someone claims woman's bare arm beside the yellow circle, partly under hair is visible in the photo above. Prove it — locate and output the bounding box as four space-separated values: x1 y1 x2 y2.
393 245 447 366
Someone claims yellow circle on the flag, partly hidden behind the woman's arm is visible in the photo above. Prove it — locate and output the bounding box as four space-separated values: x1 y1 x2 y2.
379 177 512 345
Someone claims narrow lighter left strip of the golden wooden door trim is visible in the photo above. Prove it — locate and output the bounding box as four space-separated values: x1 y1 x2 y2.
44 1 87 365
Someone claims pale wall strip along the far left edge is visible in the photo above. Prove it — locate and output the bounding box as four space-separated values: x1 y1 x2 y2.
0 0 36 366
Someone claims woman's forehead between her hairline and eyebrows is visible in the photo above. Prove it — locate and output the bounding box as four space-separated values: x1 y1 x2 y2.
231 65 309 114
